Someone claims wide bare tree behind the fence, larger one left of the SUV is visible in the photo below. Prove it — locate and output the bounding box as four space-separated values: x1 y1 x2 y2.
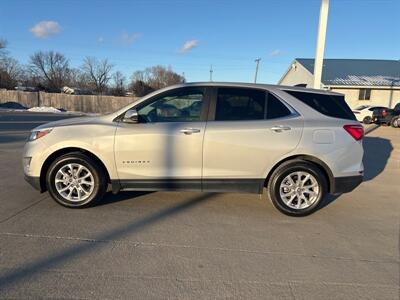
30 51 70 92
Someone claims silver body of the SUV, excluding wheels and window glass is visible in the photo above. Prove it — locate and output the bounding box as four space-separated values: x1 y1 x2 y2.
24 83 363 214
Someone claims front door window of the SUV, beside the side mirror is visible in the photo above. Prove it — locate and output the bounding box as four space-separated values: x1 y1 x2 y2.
138 90 204 123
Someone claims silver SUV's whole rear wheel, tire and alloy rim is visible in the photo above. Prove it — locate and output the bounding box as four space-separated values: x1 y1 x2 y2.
269 160 327 217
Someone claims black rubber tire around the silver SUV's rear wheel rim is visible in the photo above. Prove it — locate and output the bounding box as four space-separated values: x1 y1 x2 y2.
268 160 328 217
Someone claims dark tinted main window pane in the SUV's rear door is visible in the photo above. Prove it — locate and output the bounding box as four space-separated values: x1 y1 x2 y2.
215 88 265 121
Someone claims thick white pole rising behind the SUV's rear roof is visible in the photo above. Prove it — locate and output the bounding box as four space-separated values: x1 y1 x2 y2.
314 0 329 89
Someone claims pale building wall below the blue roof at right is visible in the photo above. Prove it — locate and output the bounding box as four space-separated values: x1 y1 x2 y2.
330 87 400 108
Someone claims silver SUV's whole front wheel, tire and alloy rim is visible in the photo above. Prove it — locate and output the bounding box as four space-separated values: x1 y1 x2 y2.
46 152 107 208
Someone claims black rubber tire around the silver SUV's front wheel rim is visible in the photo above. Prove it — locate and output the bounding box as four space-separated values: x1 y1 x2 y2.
46 152 108 208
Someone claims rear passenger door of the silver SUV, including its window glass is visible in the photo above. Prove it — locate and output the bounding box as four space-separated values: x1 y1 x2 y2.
203 87 303 193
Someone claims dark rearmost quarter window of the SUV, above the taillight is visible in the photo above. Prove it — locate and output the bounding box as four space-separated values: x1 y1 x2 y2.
285 90 356 120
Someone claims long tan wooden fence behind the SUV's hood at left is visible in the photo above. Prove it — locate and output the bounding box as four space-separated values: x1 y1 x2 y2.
0 90 139 113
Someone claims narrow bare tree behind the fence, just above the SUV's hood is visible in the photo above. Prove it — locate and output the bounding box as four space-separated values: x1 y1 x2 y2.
82 57 113 94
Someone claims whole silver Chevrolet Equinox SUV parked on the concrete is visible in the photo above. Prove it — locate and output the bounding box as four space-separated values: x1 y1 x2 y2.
23 83 364 216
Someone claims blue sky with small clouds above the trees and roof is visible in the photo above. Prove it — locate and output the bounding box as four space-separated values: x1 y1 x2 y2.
0 0 400 83
